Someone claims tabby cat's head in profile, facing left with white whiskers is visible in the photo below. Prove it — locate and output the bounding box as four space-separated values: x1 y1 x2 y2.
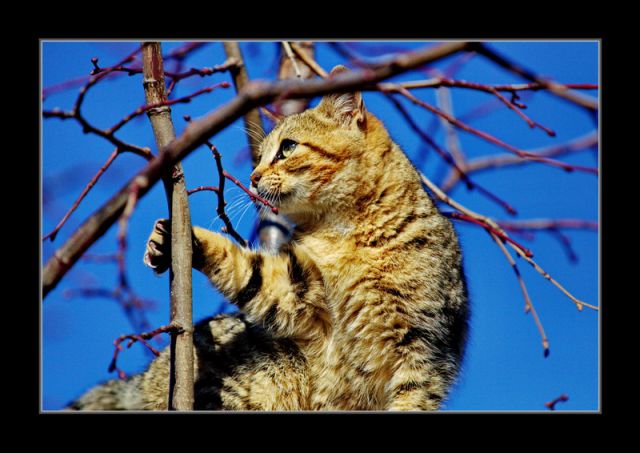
251 66 386 221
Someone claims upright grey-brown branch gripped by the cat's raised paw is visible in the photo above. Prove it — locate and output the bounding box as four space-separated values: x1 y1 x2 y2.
142 42 194 410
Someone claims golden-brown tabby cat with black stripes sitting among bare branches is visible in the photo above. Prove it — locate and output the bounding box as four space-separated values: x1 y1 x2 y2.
69 66 469 411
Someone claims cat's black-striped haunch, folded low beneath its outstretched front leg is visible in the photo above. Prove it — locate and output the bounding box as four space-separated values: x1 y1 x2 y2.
141 313 309 411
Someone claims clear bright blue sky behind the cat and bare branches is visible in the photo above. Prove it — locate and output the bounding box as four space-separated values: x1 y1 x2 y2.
42 42 599 411
